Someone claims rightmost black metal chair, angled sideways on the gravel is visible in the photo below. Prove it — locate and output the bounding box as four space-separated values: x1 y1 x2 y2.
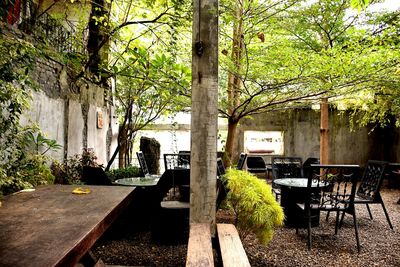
342 160 393 229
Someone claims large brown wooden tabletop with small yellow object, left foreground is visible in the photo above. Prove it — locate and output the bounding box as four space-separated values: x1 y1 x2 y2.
0 185 134 267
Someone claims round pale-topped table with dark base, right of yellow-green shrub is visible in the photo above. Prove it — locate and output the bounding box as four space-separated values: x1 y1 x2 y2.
274 178 320 228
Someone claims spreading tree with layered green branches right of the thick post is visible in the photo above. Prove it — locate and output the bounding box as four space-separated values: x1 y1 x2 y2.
220 0 396 164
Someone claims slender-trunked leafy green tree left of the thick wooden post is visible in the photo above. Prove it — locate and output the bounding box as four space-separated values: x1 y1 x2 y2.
103 1 190 169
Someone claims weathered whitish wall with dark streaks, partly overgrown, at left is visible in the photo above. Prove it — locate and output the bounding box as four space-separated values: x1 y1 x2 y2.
22 60 118 164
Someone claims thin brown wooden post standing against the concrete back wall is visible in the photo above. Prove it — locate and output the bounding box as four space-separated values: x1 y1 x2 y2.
319 98 329 164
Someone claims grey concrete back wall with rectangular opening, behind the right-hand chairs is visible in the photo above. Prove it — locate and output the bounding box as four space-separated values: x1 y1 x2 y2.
236 110 394 166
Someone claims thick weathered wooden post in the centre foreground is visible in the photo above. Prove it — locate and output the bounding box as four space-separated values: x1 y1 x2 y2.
190 0 218 229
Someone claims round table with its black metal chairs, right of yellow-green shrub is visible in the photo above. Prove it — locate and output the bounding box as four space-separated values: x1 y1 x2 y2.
272 157 393 252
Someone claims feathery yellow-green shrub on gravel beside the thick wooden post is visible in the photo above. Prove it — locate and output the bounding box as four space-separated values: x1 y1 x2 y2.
225 169 284 244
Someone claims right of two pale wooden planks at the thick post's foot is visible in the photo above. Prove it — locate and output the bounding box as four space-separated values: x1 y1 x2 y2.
217 224 250 267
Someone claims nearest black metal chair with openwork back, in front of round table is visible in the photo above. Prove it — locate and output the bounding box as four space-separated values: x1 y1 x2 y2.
296 164 360 252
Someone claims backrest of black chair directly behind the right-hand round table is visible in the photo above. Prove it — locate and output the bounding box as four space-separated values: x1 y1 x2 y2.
271 157 304 180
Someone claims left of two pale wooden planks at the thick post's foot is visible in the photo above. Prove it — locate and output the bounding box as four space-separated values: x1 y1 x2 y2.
186 223 214 267
